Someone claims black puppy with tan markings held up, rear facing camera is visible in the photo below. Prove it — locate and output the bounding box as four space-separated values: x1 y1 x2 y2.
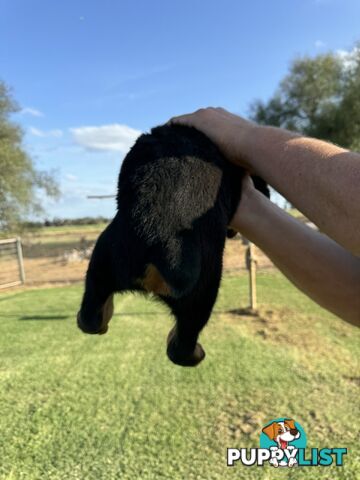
77 125 268 366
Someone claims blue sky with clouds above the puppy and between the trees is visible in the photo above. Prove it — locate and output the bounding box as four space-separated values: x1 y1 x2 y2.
0 0 360 218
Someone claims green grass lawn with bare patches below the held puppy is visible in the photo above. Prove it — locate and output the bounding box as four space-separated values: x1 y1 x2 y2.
0 274 360 480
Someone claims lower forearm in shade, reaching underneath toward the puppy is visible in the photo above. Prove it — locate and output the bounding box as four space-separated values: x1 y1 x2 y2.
232 189 360 325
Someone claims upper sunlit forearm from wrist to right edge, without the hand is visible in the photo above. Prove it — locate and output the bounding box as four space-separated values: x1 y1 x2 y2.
244 127 360 255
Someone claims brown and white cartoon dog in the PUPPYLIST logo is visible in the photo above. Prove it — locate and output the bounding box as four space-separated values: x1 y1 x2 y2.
262 419 301 467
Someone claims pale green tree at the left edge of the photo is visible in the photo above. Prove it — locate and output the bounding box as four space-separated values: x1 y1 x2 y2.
0 82 59 231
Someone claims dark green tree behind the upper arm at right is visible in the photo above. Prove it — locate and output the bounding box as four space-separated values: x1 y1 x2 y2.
251 44 360 151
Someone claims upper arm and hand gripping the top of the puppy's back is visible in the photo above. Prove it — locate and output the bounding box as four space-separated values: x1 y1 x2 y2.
171 108 360 255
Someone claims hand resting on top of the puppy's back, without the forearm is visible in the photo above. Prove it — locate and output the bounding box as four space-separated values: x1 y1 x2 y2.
169 108 259 171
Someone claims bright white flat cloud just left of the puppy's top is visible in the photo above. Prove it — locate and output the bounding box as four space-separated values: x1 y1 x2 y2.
70 123 142 153
